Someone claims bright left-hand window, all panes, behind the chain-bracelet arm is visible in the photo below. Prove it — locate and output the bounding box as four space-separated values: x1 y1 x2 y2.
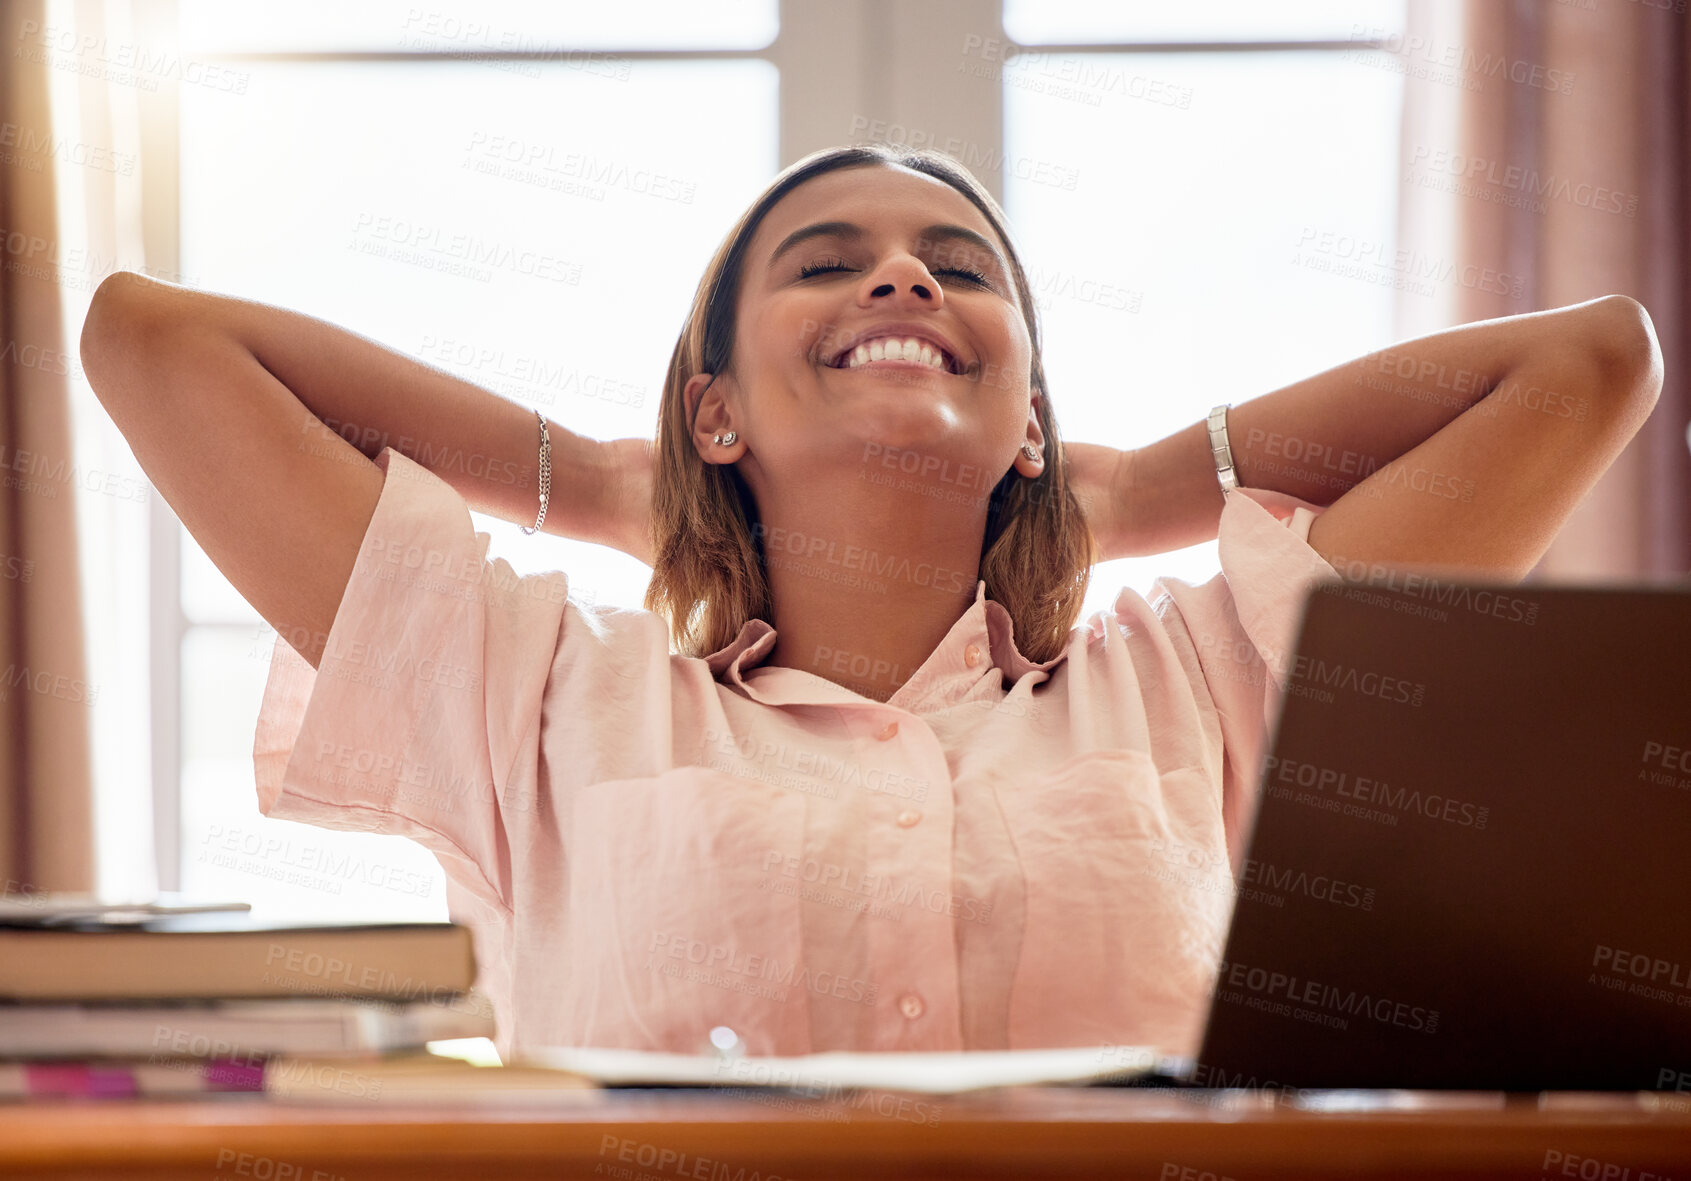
161 2 778 919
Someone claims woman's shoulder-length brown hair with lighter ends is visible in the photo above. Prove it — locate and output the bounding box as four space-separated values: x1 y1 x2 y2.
646 144 1097 663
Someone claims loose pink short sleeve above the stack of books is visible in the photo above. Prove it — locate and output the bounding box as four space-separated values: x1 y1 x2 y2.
252 448 568 910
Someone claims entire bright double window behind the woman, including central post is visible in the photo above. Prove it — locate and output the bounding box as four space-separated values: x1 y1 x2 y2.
125 0 1412 919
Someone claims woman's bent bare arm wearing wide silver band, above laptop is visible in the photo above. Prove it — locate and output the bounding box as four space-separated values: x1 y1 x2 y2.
1094 294 1662 580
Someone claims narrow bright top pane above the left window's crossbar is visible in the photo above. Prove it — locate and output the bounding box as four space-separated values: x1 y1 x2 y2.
181 0 778 53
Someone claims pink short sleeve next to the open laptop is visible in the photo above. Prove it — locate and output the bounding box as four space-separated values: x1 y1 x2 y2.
1150 487 1338 868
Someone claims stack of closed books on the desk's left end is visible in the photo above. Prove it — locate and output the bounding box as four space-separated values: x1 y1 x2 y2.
0 895 587 1101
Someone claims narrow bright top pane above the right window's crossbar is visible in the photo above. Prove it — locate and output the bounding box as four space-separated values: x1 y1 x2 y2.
1004 0 1404 46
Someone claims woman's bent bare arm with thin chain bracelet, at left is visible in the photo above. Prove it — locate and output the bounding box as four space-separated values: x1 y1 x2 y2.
81 271 649 667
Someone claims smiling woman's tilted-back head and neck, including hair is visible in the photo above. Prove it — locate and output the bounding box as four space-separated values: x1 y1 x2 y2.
646 146 1096 699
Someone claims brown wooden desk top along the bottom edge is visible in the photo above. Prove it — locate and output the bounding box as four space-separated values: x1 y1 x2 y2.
0 1088 1691 1181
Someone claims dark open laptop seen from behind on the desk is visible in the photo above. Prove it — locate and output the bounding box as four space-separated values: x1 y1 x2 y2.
1176 572 1691 1091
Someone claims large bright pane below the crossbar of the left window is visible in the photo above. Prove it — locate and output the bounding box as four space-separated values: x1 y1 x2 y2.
181 61 778 914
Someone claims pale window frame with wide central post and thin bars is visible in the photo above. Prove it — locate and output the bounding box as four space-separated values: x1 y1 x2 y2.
137 0 1383 890
